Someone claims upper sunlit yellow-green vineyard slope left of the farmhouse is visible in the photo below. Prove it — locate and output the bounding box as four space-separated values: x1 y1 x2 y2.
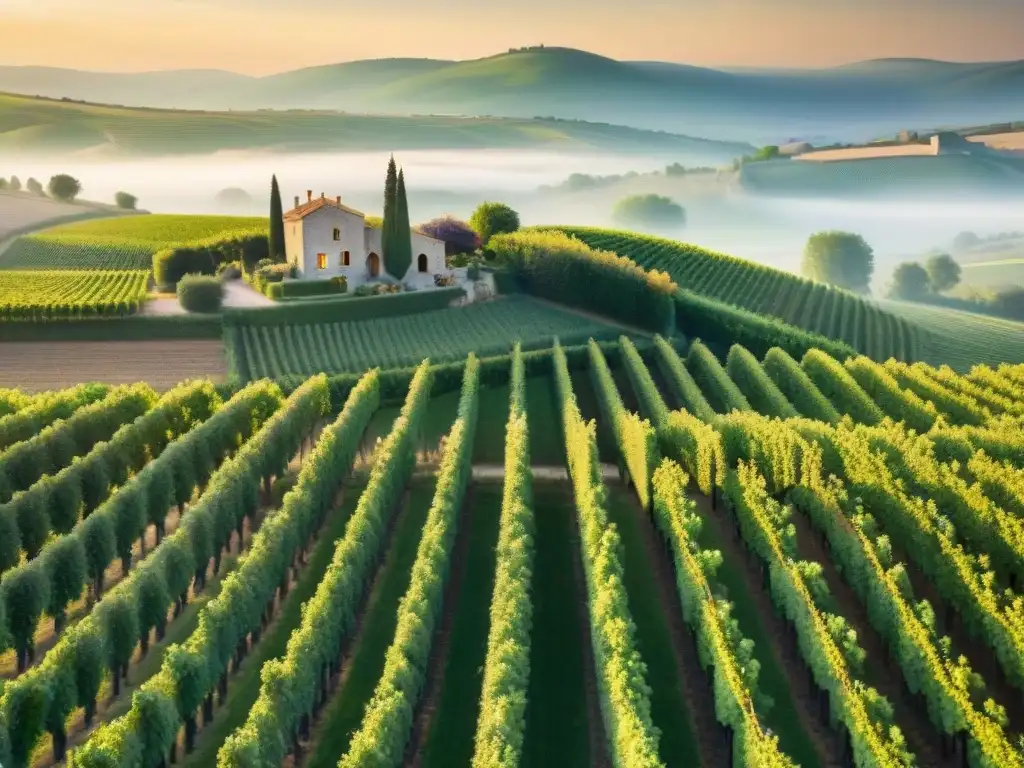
0 214 266 270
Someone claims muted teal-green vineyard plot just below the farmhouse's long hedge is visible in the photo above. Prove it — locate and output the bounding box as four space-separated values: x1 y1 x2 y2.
225 296 621 381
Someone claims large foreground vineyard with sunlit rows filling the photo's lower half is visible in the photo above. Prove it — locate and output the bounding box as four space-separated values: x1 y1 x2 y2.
0 331 1024 768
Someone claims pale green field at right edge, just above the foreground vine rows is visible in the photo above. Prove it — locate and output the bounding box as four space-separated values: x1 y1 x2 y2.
879 300 1024 372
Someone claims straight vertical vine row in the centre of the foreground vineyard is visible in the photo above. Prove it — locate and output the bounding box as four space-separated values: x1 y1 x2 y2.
472 347 535 768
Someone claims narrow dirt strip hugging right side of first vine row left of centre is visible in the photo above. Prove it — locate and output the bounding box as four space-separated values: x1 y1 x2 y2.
402 483 476 768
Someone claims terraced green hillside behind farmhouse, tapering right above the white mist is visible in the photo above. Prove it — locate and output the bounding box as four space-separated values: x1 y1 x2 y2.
0 94 753 164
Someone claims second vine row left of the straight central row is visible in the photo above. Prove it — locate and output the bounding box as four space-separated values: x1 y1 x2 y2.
217 361 430 768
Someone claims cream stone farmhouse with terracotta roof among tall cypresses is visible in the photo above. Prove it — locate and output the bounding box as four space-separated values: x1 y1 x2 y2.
284 190 450 290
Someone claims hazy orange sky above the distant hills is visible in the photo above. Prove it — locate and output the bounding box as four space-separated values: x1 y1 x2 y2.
0 0 1024 75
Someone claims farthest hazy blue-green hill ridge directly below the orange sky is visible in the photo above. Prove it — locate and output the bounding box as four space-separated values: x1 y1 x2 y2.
0 47 1024 143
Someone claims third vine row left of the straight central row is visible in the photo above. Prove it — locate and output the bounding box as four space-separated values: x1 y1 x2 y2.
72 372 380 768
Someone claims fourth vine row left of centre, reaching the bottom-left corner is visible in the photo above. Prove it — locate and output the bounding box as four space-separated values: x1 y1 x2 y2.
0 377 328 768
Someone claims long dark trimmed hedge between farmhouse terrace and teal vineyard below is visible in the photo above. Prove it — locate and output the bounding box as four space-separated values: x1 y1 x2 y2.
223 288 466 327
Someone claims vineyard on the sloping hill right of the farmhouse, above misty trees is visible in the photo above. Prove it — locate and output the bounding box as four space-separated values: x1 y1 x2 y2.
558 227 922 361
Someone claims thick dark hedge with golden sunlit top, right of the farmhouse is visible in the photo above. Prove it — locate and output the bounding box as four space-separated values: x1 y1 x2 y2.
488 231 676 334
